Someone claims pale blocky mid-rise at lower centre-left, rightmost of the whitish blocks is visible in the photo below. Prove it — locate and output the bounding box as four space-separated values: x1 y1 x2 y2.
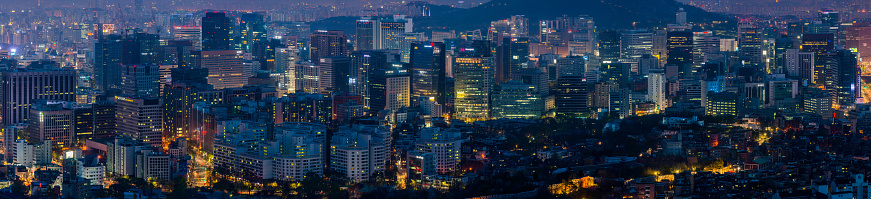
330 125 392 182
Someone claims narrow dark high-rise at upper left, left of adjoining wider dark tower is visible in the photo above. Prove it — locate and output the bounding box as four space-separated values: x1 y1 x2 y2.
94 35 122 91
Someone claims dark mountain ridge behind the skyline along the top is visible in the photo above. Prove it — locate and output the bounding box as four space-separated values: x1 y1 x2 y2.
312 0 727 34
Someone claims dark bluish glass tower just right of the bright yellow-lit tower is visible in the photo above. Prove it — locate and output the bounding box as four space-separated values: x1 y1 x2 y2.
495 37 529 83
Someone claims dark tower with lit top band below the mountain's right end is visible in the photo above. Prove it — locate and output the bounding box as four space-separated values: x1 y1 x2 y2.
666 31 693 72
